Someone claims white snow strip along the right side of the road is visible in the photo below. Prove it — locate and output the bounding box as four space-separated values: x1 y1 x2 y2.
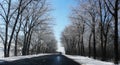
65 55 116 65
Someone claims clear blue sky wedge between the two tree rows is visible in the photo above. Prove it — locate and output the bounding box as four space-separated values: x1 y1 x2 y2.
51 0 76 51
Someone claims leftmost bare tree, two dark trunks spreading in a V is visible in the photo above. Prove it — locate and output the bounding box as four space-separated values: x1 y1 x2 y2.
0 0 32 57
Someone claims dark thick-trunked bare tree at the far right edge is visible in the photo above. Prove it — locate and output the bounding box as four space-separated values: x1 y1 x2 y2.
104 0 120 64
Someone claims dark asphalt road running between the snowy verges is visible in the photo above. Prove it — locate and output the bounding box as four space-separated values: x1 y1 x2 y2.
0 55 80 65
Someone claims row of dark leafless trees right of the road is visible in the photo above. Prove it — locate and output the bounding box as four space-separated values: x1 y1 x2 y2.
61 0 120 64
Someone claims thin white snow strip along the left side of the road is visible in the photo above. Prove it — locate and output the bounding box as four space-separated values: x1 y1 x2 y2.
0 54 51 63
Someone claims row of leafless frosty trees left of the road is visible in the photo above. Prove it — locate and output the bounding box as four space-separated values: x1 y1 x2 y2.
0 0 56 57
